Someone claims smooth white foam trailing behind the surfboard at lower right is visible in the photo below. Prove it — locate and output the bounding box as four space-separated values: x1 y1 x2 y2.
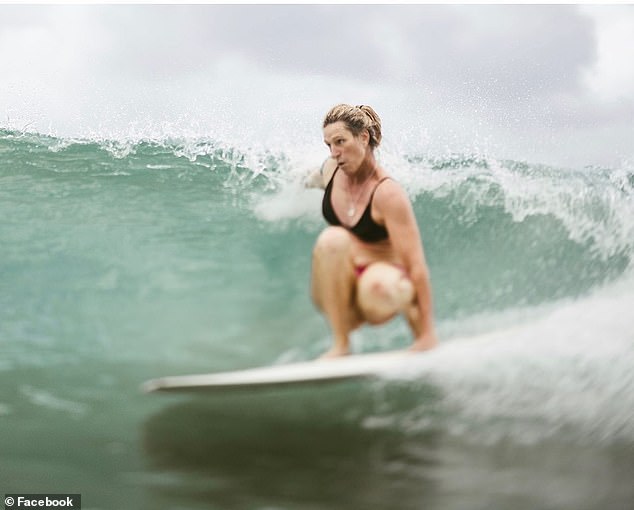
366 275 634 443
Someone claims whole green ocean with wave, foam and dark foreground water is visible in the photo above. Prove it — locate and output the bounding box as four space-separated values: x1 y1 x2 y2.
0 129 634 510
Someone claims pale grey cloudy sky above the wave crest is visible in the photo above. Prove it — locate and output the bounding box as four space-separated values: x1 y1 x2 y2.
0 4 634 168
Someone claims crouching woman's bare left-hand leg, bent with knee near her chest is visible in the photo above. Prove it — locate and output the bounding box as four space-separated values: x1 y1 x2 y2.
312 227 362 357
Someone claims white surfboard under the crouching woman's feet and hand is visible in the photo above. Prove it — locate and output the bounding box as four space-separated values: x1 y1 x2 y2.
142 350 423 393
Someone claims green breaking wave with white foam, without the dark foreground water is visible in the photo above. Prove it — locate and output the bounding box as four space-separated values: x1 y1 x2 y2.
0 131 634 450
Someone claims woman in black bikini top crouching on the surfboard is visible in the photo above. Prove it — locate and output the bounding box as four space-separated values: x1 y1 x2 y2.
312 104 437 357
